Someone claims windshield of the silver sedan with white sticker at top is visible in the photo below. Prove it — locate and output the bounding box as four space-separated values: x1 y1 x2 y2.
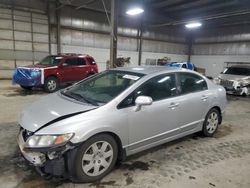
61 70 143 106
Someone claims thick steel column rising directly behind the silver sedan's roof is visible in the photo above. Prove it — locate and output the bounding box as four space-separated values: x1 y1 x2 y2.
109 0 119 68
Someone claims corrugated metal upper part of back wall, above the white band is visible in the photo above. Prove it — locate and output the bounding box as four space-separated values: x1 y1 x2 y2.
51 7 187 55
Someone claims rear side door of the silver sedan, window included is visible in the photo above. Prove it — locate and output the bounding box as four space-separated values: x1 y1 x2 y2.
177 72 212 132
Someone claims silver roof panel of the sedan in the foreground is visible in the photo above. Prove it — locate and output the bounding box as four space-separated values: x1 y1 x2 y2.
111 66 181 75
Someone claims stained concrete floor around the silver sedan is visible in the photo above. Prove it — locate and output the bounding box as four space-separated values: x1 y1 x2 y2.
0 81 250 188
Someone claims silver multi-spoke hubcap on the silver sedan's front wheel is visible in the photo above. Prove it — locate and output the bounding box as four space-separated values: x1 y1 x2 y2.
82 141 114 176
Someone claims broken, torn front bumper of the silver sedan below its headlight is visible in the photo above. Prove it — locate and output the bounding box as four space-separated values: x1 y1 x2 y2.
17 130 76 177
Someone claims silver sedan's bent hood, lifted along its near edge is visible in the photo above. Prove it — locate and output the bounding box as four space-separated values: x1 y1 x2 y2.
19 93 97 132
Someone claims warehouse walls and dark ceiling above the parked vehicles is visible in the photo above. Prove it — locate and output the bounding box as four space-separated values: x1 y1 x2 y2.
0 0 250 77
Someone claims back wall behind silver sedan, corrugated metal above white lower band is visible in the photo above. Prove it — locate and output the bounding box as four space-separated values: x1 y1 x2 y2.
48 7 187 70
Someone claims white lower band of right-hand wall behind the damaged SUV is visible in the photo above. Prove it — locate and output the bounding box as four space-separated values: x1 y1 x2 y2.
191 55 250 77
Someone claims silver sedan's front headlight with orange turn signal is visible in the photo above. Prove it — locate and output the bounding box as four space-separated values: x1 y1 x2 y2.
26 133 74 148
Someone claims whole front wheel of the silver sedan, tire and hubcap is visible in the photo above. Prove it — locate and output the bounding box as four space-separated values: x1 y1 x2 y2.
70 134 118 182
